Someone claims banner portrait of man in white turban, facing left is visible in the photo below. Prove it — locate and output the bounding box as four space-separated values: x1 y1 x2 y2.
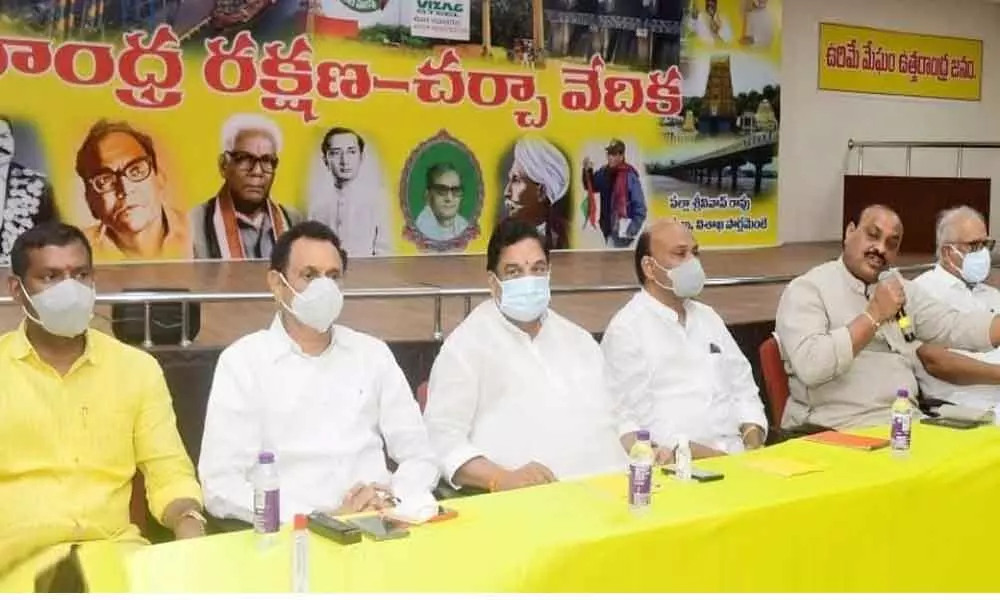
503 137 570 250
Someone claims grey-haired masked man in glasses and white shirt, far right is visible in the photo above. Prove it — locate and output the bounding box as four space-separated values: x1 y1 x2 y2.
913 206 1000 409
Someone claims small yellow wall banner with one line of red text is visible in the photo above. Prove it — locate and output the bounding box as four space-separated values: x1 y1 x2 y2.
819 23 983 100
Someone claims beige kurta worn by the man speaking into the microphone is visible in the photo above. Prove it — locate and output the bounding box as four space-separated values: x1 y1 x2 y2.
775 258 993 429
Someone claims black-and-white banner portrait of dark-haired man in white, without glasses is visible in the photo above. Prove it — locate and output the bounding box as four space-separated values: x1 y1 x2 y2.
309 127 393 258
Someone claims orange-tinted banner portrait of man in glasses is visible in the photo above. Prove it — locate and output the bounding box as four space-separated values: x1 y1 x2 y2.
76 120 191 260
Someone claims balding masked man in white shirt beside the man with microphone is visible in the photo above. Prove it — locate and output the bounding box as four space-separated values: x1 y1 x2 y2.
601 219 767 461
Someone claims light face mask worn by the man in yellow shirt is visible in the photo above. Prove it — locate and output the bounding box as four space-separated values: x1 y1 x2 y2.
21 279 97 338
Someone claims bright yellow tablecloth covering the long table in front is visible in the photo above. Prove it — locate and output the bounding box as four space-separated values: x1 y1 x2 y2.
88 426 1000 593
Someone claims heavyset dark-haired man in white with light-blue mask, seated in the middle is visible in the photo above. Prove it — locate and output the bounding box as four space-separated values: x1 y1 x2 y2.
424 219 636 492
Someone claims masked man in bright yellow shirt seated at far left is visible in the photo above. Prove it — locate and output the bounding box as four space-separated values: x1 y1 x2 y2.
0 223 204 590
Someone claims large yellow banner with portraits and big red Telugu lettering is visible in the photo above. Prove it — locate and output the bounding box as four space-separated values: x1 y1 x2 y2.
0 0 781 262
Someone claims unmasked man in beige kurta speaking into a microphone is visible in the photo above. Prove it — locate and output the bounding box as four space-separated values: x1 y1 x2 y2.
776 205 1000 430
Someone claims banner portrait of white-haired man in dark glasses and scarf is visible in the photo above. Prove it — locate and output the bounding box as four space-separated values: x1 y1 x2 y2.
189 114 302 260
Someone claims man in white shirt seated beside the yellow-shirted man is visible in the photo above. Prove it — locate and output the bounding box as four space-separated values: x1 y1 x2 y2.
199 221 439 522
